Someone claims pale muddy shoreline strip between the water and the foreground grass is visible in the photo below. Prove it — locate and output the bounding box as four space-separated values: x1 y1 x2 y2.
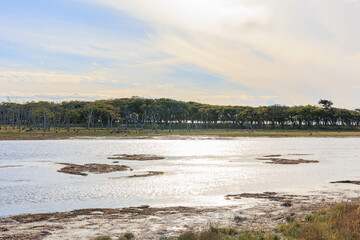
0 192 358 240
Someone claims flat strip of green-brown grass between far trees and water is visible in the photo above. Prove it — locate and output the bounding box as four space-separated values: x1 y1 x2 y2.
0 128 360 140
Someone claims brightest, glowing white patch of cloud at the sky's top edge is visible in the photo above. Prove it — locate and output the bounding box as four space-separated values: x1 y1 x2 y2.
85 0 269 32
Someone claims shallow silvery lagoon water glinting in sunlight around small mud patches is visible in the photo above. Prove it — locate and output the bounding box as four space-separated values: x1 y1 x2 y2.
0 137 360 216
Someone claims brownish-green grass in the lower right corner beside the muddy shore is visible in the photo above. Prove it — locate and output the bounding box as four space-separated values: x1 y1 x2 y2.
97 201 360 240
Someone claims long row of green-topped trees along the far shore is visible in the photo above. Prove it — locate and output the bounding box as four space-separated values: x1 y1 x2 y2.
0 97 360 131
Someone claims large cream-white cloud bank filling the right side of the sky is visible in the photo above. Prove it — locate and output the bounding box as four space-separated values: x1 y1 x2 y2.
83 0 360 106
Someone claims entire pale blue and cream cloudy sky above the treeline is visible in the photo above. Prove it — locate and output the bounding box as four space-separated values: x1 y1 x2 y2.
0 0 360 109
